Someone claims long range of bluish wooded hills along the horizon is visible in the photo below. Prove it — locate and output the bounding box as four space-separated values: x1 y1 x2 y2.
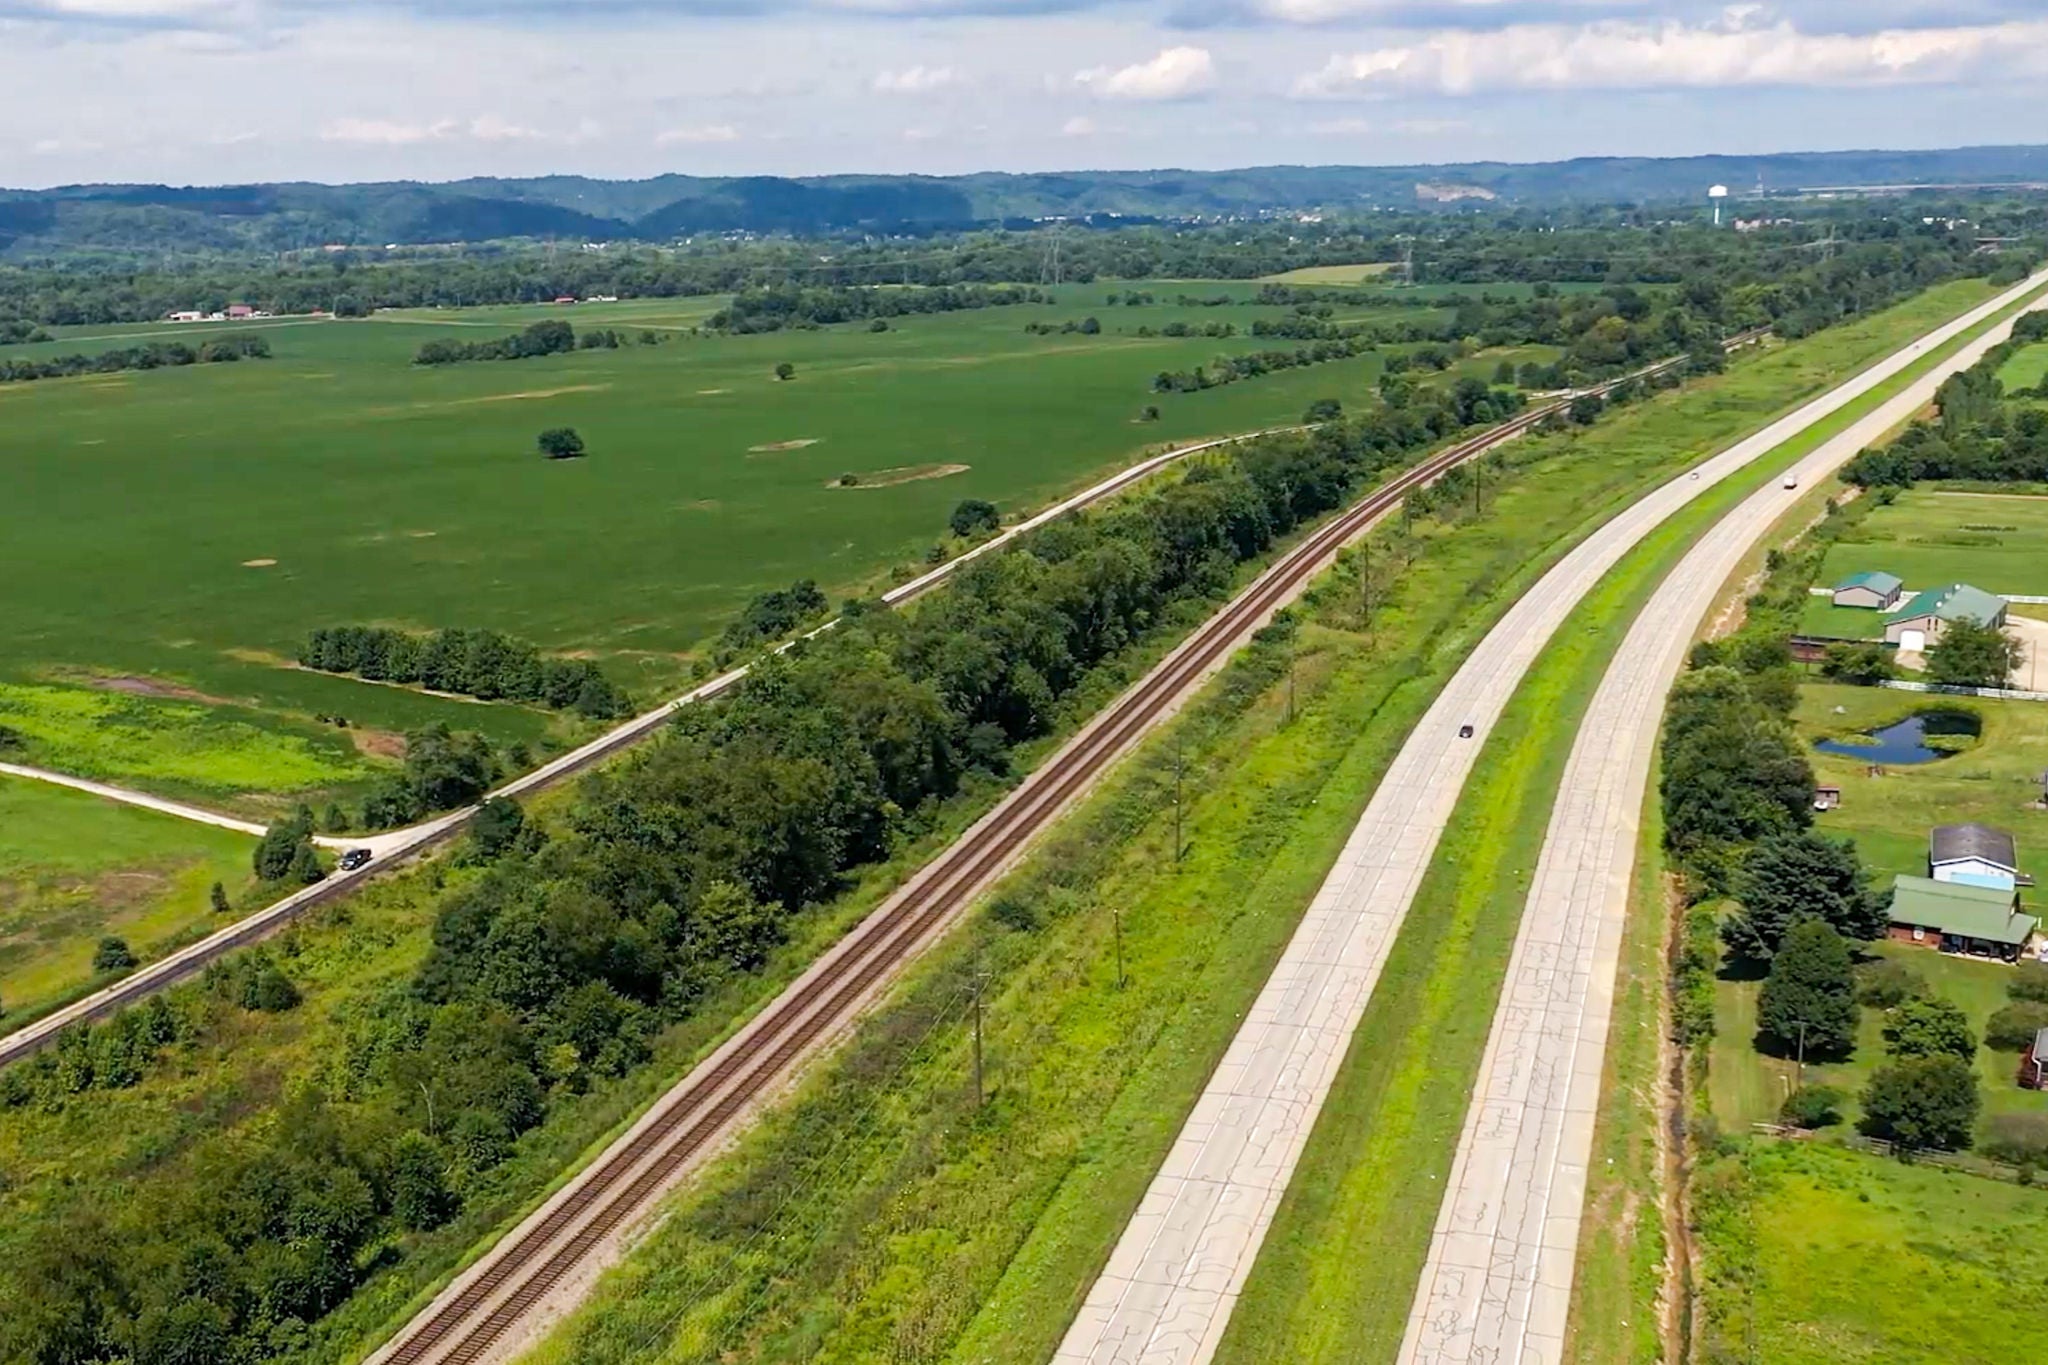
12 147 2048 258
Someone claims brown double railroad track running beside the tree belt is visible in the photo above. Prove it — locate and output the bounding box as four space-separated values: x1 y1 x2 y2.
367 351 1712 1365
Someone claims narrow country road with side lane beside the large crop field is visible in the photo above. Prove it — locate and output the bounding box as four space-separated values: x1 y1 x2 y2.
0 428 1300 1066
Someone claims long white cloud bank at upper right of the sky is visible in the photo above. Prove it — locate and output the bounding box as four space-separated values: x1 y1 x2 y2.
1294 14 2048 98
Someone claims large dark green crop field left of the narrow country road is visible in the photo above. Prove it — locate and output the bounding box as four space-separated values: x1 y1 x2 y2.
0 282 1499 790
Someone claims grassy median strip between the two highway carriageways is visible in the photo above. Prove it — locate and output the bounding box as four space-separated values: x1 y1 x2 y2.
1219 272 2048 1361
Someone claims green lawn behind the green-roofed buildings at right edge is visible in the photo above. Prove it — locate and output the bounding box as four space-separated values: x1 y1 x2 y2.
1815 489 2048 601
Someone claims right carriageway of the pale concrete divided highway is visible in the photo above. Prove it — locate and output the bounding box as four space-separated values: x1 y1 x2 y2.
1399 272 2048 1365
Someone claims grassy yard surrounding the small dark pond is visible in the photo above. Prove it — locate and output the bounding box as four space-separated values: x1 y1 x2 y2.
1794 681 2048 888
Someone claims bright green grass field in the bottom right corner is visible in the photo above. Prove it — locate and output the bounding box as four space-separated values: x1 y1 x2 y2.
1700 1142 2048 1365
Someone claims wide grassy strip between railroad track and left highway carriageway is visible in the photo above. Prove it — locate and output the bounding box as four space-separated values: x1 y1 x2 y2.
503 280 2007 1361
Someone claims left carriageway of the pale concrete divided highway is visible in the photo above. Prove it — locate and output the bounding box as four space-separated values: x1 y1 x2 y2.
1055 274 2048 1365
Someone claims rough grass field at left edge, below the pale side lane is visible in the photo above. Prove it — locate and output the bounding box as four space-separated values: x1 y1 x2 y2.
0 778 254 1027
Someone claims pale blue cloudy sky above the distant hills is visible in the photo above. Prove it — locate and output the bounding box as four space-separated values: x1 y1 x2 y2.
0 0 2048 186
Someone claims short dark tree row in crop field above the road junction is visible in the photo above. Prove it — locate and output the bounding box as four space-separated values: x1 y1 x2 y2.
299 626 633 720
